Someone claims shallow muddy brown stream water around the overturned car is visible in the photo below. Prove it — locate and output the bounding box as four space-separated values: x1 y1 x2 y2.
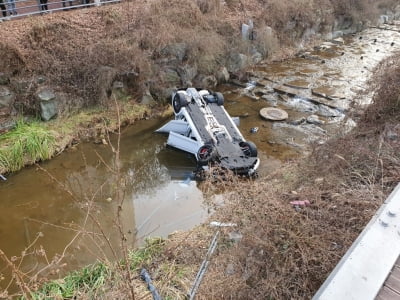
0 22 400 287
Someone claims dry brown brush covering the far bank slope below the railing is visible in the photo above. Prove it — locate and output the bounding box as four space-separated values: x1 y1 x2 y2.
0 0 396 113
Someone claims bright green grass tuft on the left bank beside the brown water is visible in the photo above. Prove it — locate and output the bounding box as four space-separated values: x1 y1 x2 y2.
0 120 56 171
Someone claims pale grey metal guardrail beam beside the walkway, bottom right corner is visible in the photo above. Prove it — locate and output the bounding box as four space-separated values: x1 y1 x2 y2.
313 183 400 300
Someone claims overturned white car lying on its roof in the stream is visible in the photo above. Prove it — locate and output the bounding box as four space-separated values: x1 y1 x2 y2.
156 88 260 175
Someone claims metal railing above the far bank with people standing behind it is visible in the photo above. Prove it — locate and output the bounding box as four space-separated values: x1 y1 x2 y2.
0 0 121 22
